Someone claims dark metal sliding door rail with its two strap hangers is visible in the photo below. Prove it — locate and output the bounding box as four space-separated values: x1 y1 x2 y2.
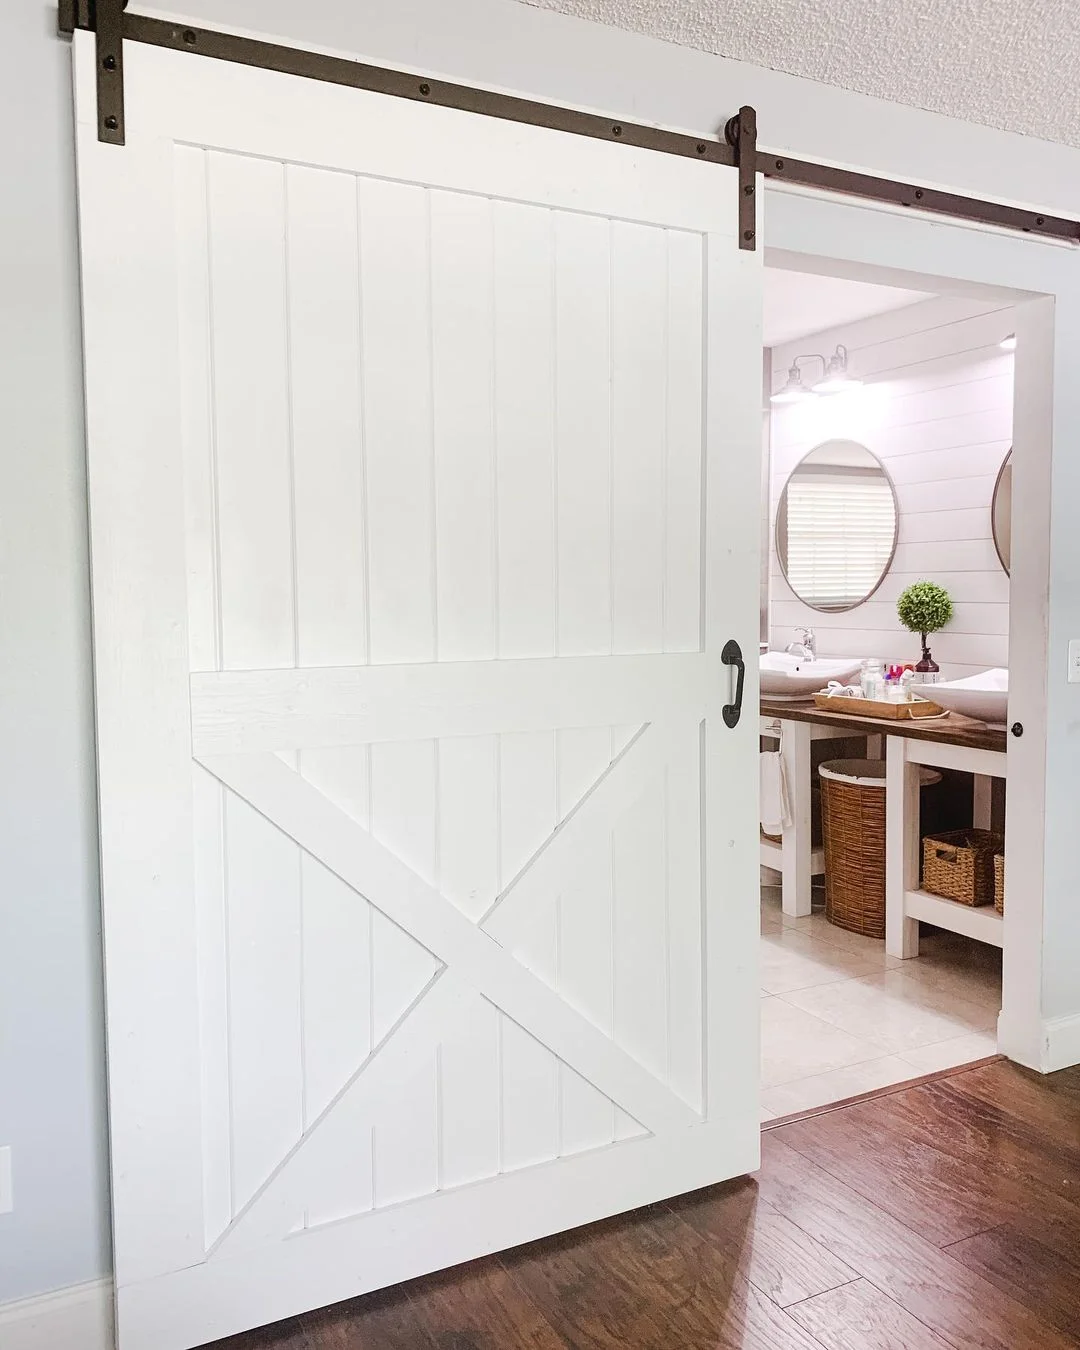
59 0 1080 248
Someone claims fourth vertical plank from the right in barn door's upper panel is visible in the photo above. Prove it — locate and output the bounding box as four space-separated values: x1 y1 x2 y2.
493 201 556 656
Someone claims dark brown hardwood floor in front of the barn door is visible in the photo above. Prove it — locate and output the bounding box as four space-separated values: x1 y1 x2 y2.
202 1061 1080 1350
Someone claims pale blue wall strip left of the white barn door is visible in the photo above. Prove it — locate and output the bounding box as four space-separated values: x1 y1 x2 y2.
0 0 109 1303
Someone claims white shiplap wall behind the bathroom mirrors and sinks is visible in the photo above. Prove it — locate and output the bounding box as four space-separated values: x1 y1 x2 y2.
770 297 1013 679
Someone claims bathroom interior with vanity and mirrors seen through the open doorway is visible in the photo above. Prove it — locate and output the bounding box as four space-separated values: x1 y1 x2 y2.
760 257 1015 1123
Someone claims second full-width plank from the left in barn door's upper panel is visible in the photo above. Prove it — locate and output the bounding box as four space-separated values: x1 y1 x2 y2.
285 165 367 666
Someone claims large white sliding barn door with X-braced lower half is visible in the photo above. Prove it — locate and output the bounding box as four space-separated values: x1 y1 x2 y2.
76 23 760 1350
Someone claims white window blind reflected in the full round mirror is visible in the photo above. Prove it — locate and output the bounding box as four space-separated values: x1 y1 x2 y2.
787 474 896 609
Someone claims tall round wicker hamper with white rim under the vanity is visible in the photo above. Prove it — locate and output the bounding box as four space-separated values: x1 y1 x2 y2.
818 760 941 938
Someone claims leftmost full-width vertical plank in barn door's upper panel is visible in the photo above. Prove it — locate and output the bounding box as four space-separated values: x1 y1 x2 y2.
207 151 296 670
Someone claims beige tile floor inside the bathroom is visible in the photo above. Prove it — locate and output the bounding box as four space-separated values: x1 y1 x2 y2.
761 886 1002 1121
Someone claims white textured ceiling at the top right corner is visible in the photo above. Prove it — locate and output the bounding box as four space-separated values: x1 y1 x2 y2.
522 0 1080 146
